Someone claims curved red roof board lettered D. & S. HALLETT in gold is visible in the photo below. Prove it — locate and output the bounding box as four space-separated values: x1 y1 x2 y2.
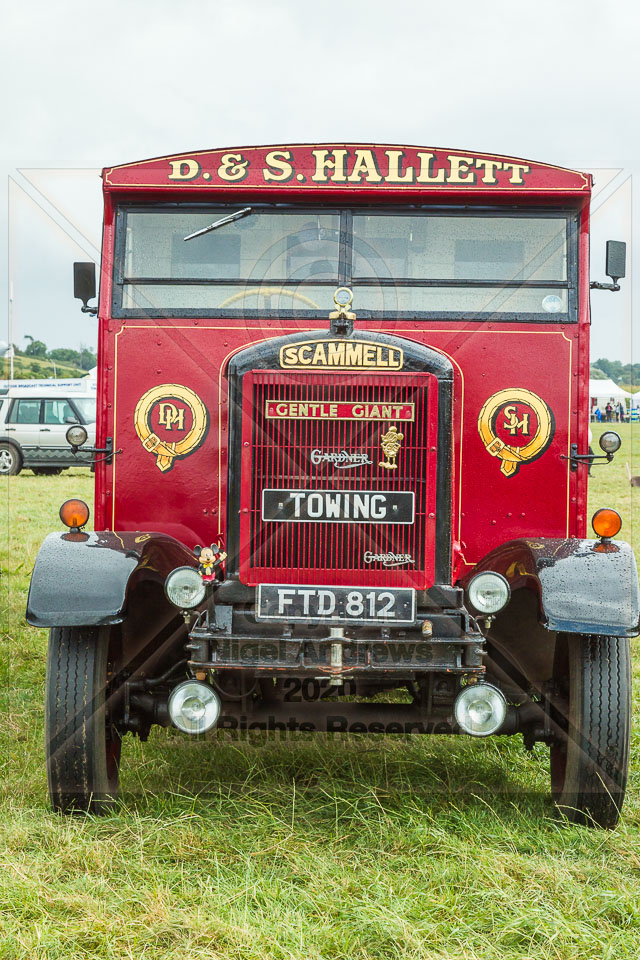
103 143 592 202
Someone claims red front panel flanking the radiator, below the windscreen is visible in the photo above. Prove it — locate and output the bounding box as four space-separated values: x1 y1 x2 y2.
96 320 586 576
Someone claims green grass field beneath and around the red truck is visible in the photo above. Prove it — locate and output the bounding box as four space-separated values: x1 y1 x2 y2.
0 424 640 960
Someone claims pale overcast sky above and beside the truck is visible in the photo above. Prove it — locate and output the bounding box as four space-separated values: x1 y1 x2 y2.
0 0 640 361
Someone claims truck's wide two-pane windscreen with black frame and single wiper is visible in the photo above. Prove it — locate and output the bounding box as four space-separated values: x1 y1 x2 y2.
114 206 575 322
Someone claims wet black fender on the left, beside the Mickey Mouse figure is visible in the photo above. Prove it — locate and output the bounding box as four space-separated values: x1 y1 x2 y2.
26 531 198 627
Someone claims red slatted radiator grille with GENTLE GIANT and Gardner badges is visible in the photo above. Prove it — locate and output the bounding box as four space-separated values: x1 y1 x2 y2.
239 370 437 589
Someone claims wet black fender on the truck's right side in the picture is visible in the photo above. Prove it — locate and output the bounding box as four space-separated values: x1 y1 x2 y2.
462 537 640 637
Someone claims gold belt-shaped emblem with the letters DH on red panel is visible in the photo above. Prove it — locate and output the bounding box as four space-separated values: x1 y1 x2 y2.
134 383 209 473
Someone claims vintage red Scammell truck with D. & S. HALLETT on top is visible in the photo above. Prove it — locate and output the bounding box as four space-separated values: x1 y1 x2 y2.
27 144 640 826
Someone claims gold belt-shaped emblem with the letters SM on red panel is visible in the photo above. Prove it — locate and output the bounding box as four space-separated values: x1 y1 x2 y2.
478 389 555 477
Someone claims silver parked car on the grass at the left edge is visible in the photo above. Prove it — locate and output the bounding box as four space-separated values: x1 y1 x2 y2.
0 387 96 475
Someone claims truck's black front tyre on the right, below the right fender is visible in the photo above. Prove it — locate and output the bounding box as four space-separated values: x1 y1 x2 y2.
551 634 631 827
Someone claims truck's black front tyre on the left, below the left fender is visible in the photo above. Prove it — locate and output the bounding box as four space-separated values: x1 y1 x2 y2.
45 627 121 814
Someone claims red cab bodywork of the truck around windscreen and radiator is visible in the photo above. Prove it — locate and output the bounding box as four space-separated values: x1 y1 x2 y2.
96 145 591 576
